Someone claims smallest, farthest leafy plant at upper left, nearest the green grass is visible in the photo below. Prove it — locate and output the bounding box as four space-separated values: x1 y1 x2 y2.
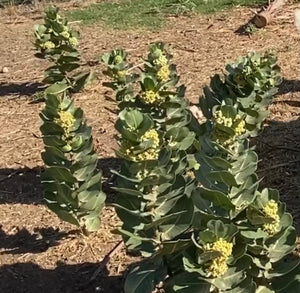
34 6 94 92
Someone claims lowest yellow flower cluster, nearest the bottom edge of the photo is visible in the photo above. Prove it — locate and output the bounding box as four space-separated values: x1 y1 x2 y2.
203 238 233 278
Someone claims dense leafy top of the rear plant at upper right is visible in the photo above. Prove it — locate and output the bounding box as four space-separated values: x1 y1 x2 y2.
200 52 281 140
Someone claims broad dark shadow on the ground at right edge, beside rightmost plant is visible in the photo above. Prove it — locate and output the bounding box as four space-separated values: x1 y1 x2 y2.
251 110 300 233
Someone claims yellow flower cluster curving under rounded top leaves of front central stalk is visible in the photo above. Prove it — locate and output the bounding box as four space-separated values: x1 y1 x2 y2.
121 129 160 162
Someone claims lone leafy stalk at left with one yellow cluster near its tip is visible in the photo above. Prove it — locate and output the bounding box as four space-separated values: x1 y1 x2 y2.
40 93 105 232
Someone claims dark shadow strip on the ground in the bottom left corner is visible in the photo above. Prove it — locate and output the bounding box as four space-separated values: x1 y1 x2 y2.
0 262 123 293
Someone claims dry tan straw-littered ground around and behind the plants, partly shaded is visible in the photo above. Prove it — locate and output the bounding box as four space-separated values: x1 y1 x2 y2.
0 2 300 293
